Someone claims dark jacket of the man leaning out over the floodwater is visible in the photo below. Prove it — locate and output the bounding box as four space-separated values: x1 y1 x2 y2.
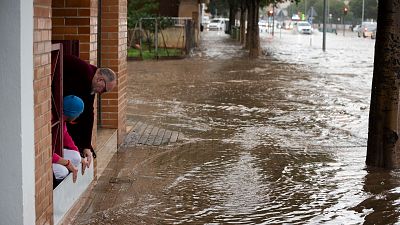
63 55 97 153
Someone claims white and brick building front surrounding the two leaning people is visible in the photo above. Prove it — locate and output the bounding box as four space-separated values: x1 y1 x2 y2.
0 0 200 225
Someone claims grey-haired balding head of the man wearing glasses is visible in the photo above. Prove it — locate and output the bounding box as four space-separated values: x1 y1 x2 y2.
92 68 117 94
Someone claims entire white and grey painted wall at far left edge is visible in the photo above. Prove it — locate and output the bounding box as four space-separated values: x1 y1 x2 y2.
0 0 35 225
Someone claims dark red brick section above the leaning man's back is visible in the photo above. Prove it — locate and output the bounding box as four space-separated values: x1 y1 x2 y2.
52 0 97 65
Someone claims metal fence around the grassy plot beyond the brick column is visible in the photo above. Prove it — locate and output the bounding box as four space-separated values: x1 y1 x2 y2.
128 17 195 59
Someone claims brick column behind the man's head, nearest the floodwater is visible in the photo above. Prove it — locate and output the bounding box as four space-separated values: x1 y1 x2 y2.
100 0 127 143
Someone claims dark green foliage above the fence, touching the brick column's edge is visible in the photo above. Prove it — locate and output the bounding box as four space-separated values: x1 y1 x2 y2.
128 0 159 28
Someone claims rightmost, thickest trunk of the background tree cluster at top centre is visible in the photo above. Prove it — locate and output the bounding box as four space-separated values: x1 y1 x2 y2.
249 0 261 58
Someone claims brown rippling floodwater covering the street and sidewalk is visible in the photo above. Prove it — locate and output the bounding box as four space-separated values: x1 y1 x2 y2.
75 31 400 225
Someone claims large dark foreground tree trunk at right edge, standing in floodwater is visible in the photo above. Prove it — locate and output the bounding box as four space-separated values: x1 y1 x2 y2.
366 0 400 168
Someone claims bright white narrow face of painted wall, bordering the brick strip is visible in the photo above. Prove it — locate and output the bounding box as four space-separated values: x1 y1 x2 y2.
19 0 36 224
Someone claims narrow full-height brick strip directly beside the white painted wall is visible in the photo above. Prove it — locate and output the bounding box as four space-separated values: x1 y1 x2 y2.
33 0 53 225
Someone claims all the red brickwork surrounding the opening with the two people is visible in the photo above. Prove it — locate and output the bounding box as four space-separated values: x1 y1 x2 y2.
33 0 127 225
